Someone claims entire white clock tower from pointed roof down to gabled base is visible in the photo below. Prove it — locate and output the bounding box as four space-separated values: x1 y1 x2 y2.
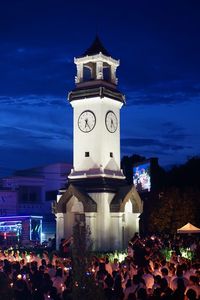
54 37 142 250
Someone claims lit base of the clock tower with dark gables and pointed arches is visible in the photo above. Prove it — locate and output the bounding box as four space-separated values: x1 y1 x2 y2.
54 180 143 251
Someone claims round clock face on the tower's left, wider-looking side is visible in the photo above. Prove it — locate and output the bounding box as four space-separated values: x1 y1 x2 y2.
78 110 96 132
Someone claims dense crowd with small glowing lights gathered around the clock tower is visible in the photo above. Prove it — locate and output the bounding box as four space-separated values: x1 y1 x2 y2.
0 234 200 300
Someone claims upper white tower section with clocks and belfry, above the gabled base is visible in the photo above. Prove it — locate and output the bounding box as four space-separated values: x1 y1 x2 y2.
69 37 125 179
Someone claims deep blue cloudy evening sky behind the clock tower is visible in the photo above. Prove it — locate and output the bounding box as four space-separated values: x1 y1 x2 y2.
0 0 200 176
